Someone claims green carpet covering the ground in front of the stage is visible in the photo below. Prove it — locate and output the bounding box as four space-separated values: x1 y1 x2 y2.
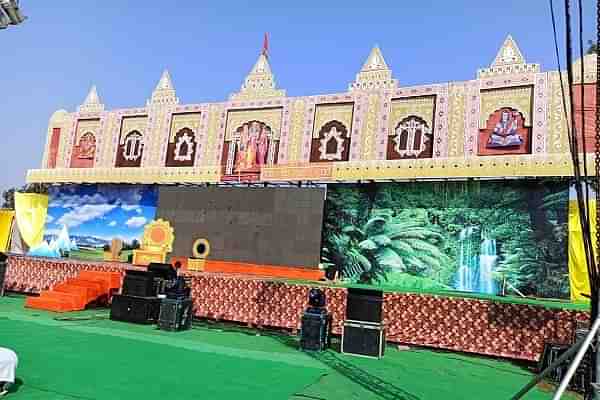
0 296 575 400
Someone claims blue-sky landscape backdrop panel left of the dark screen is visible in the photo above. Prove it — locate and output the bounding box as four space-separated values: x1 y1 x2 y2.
33 185 158 259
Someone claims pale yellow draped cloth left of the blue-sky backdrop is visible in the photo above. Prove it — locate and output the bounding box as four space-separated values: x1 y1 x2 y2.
15 193 48 247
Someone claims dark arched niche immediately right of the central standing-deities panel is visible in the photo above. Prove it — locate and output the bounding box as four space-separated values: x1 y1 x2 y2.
310 120 350 162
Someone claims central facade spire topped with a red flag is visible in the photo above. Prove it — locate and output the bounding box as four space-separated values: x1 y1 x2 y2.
229 34 285 100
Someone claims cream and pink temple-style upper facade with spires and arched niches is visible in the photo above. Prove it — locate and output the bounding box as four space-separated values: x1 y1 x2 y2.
27 36 596 184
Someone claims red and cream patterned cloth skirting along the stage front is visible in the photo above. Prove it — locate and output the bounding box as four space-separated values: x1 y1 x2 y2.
6 256 588 361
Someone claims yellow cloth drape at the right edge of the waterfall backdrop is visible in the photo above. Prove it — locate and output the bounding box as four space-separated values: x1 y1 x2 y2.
569 200 598 302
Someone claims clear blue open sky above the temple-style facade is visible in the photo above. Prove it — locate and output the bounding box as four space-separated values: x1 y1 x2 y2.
0 0 595 195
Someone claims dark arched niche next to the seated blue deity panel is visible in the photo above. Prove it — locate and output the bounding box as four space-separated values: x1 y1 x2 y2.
387 115 433 160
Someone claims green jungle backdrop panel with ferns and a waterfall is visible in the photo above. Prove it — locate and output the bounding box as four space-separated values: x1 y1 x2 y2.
321 180 569 298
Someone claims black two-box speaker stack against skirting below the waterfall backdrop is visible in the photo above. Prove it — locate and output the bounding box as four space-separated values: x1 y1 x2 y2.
341 288 385 358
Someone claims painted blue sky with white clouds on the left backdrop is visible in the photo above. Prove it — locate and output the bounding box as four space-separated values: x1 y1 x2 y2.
45 185 158 241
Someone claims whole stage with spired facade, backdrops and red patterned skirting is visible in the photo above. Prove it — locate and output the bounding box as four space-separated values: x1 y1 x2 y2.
7 36 597 360
